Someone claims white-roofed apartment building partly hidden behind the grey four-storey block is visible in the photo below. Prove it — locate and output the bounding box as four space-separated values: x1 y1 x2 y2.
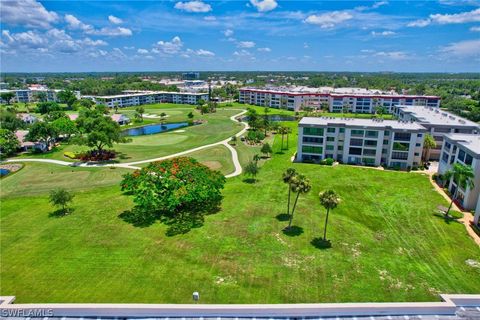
393 105 480 160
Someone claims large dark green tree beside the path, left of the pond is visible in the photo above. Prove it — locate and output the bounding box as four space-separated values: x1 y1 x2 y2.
73 106 130 153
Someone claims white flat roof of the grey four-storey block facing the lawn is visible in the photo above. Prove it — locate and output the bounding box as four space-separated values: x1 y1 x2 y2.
299 117 426 131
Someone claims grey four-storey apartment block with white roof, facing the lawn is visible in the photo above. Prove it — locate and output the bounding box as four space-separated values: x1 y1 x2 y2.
296 117 426 169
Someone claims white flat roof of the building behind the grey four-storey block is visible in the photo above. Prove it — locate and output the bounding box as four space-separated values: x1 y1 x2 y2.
396 105 480 128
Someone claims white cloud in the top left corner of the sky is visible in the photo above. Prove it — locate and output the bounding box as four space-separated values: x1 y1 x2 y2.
0 0 59 29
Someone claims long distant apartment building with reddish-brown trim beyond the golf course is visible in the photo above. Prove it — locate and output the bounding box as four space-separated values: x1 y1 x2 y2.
239 87 440 113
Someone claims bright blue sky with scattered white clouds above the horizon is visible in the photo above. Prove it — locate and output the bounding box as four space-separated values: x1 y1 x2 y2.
0 0 480 72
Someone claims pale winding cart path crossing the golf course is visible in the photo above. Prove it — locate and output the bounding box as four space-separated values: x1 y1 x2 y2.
6 109 248 178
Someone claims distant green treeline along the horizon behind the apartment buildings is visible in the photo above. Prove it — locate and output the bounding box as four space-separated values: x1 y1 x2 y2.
1 72 480 121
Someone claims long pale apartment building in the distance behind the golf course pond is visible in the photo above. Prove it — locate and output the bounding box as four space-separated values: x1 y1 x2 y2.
94 91 208 108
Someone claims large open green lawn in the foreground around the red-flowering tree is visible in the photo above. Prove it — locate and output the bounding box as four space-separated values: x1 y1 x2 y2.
0 126 480 303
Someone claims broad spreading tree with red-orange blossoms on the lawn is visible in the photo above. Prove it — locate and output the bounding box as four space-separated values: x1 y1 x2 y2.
121 157 226 232
